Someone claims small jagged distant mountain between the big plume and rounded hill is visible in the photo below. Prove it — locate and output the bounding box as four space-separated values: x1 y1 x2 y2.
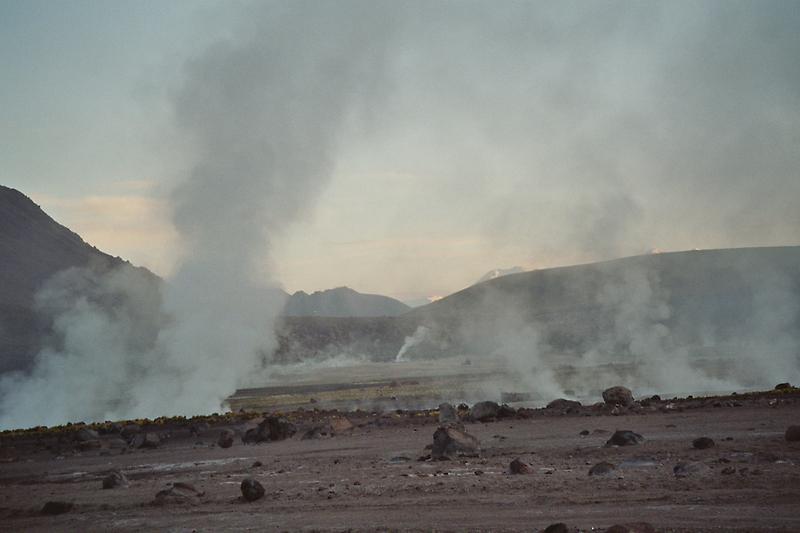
283 287 411 317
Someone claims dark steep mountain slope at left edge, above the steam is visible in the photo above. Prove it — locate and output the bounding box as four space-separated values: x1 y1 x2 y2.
0 185 158 372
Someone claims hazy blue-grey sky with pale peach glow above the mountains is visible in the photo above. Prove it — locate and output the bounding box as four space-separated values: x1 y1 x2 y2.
0 0 800 298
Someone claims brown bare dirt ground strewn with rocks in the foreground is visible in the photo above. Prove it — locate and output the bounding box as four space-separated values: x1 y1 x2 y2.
0 389 800 532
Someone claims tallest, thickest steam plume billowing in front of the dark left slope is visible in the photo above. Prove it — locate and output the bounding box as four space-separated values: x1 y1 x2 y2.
0 2 388 428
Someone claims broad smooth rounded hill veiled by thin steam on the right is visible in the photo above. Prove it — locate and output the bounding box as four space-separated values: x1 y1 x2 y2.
410 246 800 355
